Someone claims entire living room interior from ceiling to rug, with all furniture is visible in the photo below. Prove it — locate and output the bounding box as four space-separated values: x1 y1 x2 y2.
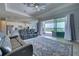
0 3 79 56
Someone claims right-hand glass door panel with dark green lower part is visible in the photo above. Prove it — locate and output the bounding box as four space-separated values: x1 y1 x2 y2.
56 17 66 38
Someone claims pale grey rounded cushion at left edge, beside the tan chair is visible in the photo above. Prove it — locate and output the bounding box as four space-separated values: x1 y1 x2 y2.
0 32 12 55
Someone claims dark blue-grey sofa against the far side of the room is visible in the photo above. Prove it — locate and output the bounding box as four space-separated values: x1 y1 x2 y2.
19 29 38 40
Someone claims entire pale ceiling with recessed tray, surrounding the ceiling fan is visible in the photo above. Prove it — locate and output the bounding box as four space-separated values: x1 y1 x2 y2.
0 3 79 22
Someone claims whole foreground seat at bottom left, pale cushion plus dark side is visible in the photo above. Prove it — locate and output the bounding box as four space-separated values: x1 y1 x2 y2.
0 32 33 56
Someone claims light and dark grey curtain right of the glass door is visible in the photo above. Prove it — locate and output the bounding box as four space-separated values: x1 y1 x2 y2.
64 14 76 41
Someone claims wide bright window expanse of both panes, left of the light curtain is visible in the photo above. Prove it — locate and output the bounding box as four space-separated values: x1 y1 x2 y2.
44 17 66 37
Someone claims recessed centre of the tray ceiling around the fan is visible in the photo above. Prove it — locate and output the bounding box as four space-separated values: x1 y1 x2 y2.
7 3 64 17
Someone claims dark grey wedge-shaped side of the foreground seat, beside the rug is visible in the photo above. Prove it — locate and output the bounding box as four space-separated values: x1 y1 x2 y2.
6 44 33 56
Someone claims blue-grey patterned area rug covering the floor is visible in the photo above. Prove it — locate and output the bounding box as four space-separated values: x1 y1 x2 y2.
24 37 72 56
